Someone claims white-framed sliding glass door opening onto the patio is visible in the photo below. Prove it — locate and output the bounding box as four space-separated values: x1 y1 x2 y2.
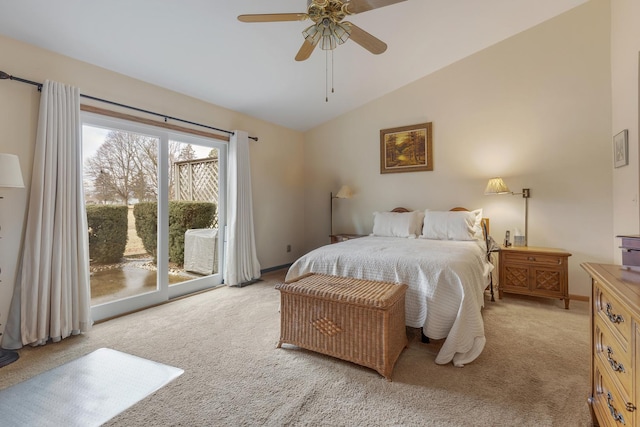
83 113 227 320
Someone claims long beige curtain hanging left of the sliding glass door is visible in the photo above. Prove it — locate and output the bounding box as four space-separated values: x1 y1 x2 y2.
2 81 92 349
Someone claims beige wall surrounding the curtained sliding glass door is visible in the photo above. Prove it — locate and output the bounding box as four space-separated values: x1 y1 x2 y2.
0 37 304 331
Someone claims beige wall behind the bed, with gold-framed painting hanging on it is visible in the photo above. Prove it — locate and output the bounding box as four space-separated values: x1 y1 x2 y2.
304 0 612 295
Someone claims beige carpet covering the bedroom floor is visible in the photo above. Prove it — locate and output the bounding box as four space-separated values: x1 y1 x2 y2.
0 271 590 427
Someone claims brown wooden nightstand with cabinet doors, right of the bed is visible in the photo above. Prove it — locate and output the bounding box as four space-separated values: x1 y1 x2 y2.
498 246 571 309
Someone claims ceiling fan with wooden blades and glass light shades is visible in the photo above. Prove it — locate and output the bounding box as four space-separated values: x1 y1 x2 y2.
238 0 406 61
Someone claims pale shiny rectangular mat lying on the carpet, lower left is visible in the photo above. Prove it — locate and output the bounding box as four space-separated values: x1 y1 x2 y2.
0 348 184 427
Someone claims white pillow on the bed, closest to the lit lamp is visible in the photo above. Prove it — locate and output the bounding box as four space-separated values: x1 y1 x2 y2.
420 210 477 240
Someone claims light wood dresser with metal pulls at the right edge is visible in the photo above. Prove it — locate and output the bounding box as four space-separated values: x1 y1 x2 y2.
582 263 640 426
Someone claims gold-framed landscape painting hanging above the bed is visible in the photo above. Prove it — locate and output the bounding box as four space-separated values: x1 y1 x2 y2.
380 122 433 173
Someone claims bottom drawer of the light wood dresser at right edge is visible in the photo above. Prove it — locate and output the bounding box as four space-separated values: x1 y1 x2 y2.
591 359 635 427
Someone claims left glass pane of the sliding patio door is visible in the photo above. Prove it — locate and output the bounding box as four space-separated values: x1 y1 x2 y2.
82 124 165 305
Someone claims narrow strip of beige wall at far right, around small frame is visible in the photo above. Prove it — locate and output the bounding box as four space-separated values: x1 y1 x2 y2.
611 0 640 264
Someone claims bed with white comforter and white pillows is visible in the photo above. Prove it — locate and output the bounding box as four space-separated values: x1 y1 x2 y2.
286 208 493 366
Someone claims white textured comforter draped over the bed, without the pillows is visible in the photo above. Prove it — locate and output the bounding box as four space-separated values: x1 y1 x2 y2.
286 236 493 366
